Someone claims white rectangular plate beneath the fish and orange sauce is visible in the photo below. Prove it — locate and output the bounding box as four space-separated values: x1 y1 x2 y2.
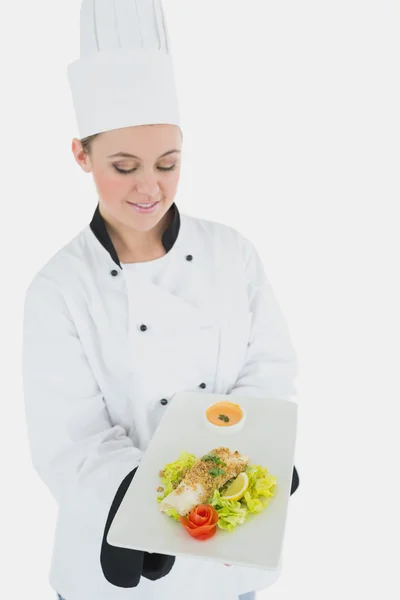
107 392 297 570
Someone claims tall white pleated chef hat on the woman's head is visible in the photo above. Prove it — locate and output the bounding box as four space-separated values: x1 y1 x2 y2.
67 0 180 138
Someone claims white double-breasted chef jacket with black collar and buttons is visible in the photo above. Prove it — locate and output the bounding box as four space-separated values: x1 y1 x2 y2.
22 204 299 600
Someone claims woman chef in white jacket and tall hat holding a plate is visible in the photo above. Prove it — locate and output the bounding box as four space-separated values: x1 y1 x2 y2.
23 0 298 600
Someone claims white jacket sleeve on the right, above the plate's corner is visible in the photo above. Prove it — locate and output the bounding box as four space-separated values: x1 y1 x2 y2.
229 237 299 494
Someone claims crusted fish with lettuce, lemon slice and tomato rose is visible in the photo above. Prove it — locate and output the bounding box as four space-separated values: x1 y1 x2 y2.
157 447 276 540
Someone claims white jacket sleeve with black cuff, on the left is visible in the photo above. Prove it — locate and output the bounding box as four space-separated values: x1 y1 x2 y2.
22 274 175 587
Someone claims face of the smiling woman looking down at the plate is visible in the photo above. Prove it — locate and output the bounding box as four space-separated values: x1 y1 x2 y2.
72 124 182 231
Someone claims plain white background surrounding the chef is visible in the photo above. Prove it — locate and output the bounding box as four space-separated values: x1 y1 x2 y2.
0 0 400 600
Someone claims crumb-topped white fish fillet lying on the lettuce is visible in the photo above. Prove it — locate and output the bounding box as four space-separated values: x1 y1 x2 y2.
160 447 249 516
